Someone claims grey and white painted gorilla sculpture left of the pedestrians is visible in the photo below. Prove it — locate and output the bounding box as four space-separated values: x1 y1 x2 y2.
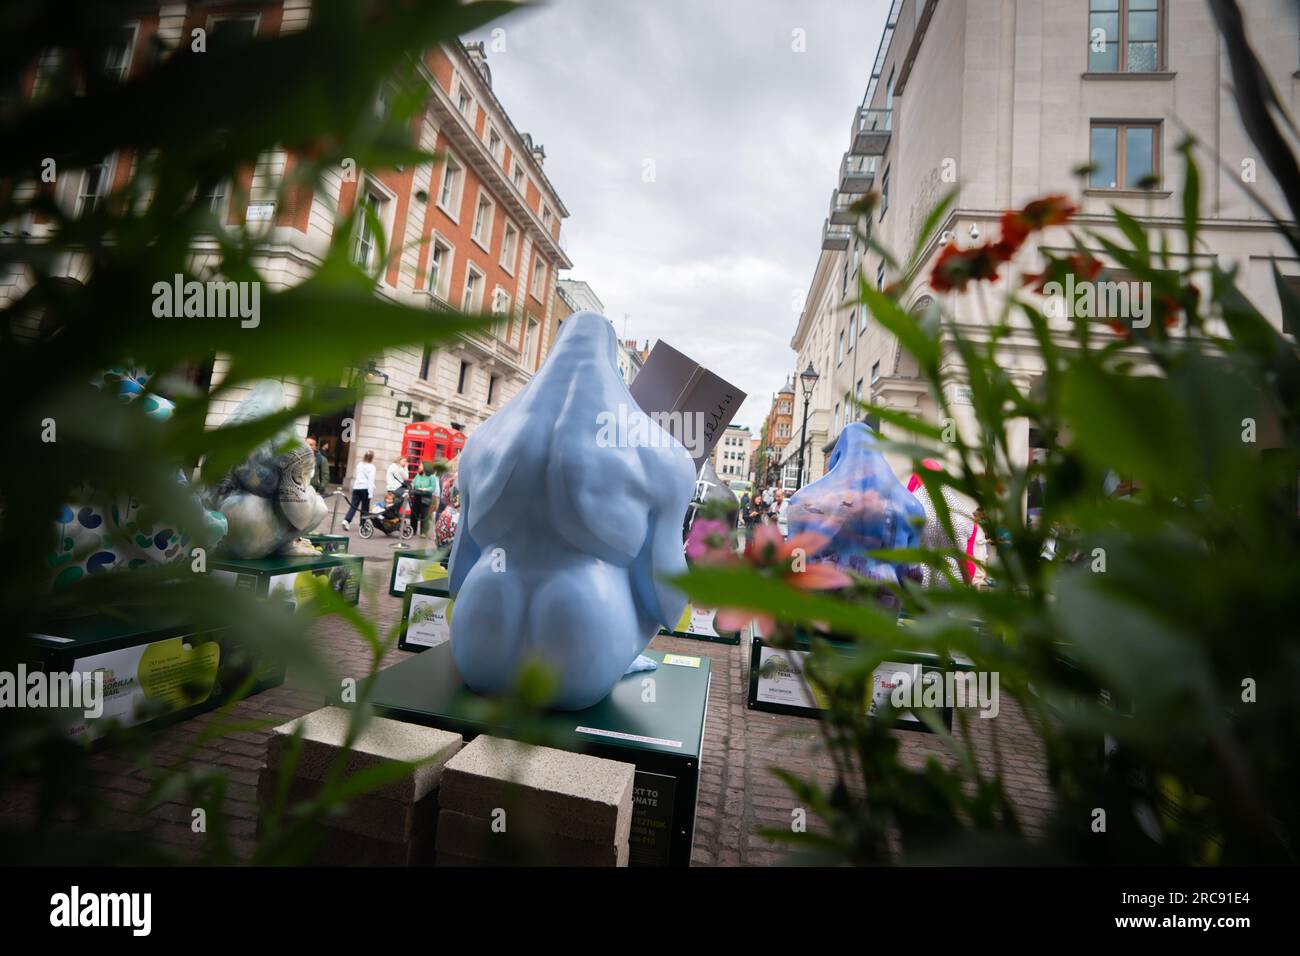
205 381 325 558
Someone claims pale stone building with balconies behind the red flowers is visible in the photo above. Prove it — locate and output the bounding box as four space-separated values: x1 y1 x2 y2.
783 0 1300 483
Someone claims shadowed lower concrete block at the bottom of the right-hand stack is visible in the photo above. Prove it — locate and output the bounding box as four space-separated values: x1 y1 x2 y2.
437 810 628 866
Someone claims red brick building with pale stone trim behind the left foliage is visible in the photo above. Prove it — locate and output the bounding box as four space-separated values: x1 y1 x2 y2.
0 0 571 481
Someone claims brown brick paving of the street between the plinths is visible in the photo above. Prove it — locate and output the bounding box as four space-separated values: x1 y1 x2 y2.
0 535 1052 866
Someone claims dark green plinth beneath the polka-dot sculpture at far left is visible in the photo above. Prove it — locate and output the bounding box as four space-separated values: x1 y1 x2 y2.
23 607 285 740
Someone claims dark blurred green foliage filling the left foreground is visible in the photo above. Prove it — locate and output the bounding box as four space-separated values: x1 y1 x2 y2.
0 0 512 862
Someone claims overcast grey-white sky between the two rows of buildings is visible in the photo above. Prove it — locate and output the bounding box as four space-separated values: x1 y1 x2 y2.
465 0 889 434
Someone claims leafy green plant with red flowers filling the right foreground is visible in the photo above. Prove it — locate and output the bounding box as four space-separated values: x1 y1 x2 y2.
683 16 1300 865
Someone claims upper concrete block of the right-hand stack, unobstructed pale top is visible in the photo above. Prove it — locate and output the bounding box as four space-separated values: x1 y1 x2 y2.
438 735 636 847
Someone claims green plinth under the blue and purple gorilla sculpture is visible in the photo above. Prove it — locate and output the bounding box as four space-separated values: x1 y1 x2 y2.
748 628 971 734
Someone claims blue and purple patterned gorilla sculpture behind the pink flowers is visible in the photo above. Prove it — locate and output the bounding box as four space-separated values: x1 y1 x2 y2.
788 421 926 584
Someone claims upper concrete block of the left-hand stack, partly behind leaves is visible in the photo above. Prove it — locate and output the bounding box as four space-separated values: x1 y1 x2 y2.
267 706 464 804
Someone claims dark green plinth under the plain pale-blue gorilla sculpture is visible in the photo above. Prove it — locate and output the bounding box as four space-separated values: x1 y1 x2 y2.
356 644 710 866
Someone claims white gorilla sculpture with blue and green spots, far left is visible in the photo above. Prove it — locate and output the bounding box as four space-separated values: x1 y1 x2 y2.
48 367 226 588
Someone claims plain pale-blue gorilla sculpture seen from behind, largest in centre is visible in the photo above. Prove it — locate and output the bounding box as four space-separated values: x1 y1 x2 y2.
450 312 696 710
